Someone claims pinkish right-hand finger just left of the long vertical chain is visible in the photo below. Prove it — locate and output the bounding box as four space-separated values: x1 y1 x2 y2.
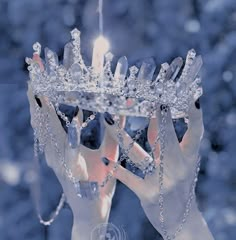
147 118 160 161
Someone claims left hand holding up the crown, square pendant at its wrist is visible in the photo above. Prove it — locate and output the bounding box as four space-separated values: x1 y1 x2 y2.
28 54 125 240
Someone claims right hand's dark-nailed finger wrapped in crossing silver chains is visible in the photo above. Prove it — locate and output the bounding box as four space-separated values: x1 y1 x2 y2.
104 113 153 170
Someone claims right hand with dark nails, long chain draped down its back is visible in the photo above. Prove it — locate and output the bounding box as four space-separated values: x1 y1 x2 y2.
105 102 213 240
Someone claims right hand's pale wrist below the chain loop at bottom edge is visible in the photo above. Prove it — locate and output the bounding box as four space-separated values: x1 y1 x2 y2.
173 206 214 240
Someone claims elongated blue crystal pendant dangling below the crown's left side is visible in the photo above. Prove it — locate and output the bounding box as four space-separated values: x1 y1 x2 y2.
68 119 80 149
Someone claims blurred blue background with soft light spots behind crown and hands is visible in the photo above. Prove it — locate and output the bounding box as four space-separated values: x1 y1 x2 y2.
0 0 236 240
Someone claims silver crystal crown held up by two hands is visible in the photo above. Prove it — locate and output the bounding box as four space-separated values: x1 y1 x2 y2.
26 29 202 118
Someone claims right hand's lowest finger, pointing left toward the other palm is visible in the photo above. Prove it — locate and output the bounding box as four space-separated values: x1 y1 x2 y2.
104 162 145 196
